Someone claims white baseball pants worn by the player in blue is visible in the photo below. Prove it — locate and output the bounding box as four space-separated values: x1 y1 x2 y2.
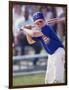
45 48 65 84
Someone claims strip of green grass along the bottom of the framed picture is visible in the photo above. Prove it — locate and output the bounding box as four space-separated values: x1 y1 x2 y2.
13 73 45 86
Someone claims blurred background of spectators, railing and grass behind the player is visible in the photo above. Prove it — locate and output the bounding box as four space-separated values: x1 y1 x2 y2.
12 4 66 86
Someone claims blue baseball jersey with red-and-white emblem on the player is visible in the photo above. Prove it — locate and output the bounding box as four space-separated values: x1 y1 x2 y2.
33 25 63 54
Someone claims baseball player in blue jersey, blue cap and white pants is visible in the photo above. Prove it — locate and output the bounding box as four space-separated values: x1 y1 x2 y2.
21 12 65 84
